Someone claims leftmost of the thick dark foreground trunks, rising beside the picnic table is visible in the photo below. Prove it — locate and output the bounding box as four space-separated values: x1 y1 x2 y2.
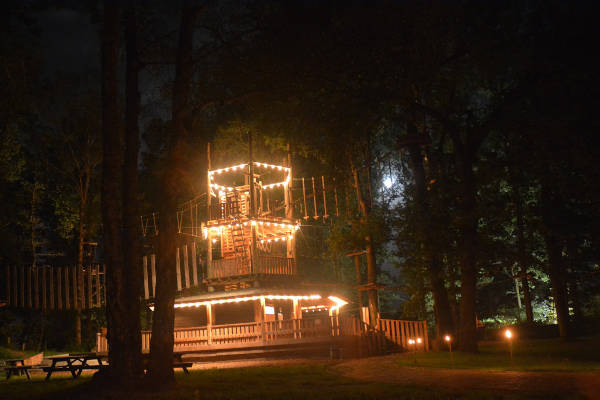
100 1 142 386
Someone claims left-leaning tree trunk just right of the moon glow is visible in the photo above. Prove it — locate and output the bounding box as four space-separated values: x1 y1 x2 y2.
408 138 454 346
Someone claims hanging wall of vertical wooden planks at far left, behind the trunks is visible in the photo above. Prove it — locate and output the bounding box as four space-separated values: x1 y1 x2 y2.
0 265 106 310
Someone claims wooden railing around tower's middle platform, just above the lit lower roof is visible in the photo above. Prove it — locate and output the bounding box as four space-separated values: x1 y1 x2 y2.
208 256 296 279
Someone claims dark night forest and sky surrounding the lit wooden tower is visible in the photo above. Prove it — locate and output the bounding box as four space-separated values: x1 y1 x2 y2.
0 0 600 382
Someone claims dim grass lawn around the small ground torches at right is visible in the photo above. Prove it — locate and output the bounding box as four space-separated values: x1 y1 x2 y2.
399 336 600 372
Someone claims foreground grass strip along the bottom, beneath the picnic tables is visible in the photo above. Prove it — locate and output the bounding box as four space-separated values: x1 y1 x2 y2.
0 364 544 400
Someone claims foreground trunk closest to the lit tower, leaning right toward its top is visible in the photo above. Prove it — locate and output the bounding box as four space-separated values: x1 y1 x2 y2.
149 2 199 385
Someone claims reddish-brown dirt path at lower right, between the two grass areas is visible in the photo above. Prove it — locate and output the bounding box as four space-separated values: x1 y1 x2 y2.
331 355 600 400
